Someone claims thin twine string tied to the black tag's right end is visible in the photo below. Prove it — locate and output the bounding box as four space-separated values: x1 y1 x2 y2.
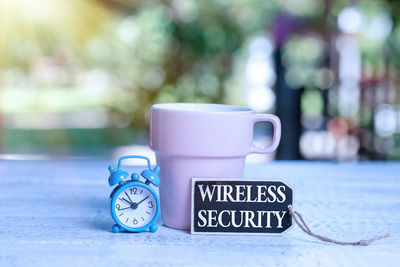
288 205 389 246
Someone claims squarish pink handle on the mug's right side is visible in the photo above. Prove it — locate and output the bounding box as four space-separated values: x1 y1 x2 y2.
251 114 281 154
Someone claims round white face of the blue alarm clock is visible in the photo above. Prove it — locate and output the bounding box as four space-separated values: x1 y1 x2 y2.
112 186 157 228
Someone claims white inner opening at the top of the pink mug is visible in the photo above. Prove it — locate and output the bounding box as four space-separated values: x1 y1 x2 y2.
151 103 253 113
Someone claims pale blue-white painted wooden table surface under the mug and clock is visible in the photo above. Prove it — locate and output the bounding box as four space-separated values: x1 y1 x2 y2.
0 160 400 266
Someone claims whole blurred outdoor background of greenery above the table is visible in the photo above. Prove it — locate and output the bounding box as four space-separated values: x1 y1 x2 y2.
0 0 400 161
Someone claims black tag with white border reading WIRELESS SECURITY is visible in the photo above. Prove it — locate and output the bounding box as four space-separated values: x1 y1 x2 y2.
191 178 293 235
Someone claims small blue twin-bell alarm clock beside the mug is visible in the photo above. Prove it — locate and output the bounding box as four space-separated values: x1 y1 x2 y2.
108 155 160 233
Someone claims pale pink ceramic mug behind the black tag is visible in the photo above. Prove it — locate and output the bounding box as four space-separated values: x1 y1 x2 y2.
150 103 281 229
